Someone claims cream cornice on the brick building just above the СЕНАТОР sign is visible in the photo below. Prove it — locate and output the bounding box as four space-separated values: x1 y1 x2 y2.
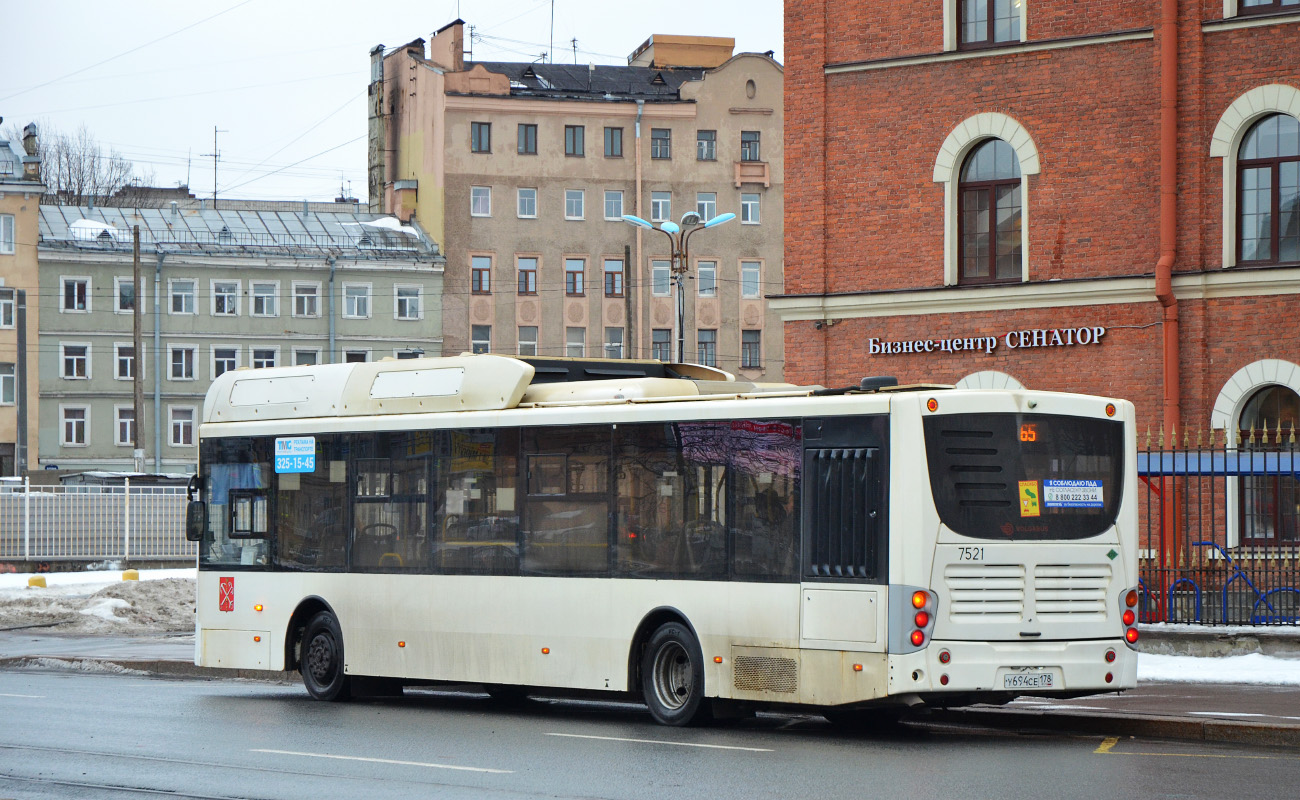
768 267 1300 321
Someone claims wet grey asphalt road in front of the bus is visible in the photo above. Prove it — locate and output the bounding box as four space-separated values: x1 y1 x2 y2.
0 671 1300 800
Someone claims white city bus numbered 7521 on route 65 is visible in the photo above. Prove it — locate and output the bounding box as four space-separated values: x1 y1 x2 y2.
187 355 1138 725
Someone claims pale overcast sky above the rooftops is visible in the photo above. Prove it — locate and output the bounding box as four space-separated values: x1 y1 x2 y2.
0 0 784 206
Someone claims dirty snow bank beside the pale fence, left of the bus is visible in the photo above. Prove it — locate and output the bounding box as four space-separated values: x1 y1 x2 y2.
0 570 194 633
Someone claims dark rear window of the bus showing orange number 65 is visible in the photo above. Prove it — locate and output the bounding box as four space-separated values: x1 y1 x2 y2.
924 414 1125 541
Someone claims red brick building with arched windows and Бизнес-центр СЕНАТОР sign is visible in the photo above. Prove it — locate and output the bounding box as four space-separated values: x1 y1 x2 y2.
772 0 1300 440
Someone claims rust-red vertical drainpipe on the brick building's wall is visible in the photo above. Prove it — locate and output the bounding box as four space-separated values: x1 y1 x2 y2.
1156 0 1182 431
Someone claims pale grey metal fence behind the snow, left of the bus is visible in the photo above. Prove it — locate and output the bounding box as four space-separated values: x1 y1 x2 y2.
0 480 198 562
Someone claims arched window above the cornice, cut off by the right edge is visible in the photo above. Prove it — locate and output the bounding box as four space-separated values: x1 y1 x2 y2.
1236 114 1300 264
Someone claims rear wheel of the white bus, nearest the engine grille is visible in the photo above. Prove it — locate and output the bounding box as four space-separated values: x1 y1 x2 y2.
641 622 710 726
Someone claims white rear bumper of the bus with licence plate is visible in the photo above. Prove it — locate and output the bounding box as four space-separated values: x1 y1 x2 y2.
889 637 1138 697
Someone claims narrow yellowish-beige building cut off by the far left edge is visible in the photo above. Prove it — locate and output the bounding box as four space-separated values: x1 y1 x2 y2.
0 126 46 477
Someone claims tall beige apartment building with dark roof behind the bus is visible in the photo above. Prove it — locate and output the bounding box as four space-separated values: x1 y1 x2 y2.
369 20 784 381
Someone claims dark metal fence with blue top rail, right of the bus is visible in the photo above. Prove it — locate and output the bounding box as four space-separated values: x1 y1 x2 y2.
1138 429 1300 626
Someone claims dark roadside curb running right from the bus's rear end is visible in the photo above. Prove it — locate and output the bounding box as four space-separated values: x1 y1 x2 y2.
917 708 1300 747
